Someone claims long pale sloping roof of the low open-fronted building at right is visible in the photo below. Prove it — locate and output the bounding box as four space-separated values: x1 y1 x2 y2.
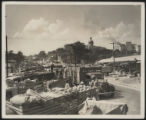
97 55 141 63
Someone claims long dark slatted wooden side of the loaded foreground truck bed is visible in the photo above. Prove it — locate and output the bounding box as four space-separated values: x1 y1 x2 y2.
7 88 97 115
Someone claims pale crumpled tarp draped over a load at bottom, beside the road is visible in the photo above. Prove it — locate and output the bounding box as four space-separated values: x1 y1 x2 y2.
78 99 128 115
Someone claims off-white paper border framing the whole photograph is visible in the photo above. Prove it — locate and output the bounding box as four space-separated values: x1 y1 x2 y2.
1 1 145 119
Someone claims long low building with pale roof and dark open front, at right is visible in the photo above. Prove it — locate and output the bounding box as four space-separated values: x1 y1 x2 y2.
97 55 141 75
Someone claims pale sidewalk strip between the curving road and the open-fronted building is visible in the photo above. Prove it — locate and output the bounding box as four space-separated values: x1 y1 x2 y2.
105 76 140 91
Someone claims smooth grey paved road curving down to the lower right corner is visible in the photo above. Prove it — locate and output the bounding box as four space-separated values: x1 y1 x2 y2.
102 86 140 115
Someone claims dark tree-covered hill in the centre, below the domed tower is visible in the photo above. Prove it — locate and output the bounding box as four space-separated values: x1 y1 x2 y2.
48 41 112 64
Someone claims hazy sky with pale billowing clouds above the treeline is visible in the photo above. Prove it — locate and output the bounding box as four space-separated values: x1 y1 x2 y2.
6 5 141 55
